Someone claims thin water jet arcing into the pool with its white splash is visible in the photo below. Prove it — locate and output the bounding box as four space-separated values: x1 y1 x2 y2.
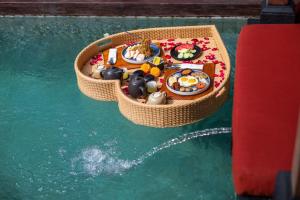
71 127 231 176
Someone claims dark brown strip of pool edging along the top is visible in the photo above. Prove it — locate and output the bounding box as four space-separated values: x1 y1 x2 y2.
0 0 261 17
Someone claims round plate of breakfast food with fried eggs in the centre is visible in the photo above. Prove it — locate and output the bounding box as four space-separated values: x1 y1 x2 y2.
166 69 210 96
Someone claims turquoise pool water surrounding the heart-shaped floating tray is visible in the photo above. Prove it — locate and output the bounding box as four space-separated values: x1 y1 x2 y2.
0 17 246 200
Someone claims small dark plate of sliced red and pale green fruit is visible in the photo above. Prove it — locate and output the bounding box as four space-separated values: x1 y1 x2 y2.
170 44 201 61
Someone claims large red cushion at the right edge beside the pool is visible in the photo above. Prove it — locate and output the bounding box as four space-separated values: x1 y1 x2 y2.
233 25 300 196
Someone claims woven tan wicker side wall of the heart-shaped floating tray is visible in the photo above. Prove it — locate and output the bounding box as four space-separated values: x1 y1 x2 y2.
74 25 230 127
